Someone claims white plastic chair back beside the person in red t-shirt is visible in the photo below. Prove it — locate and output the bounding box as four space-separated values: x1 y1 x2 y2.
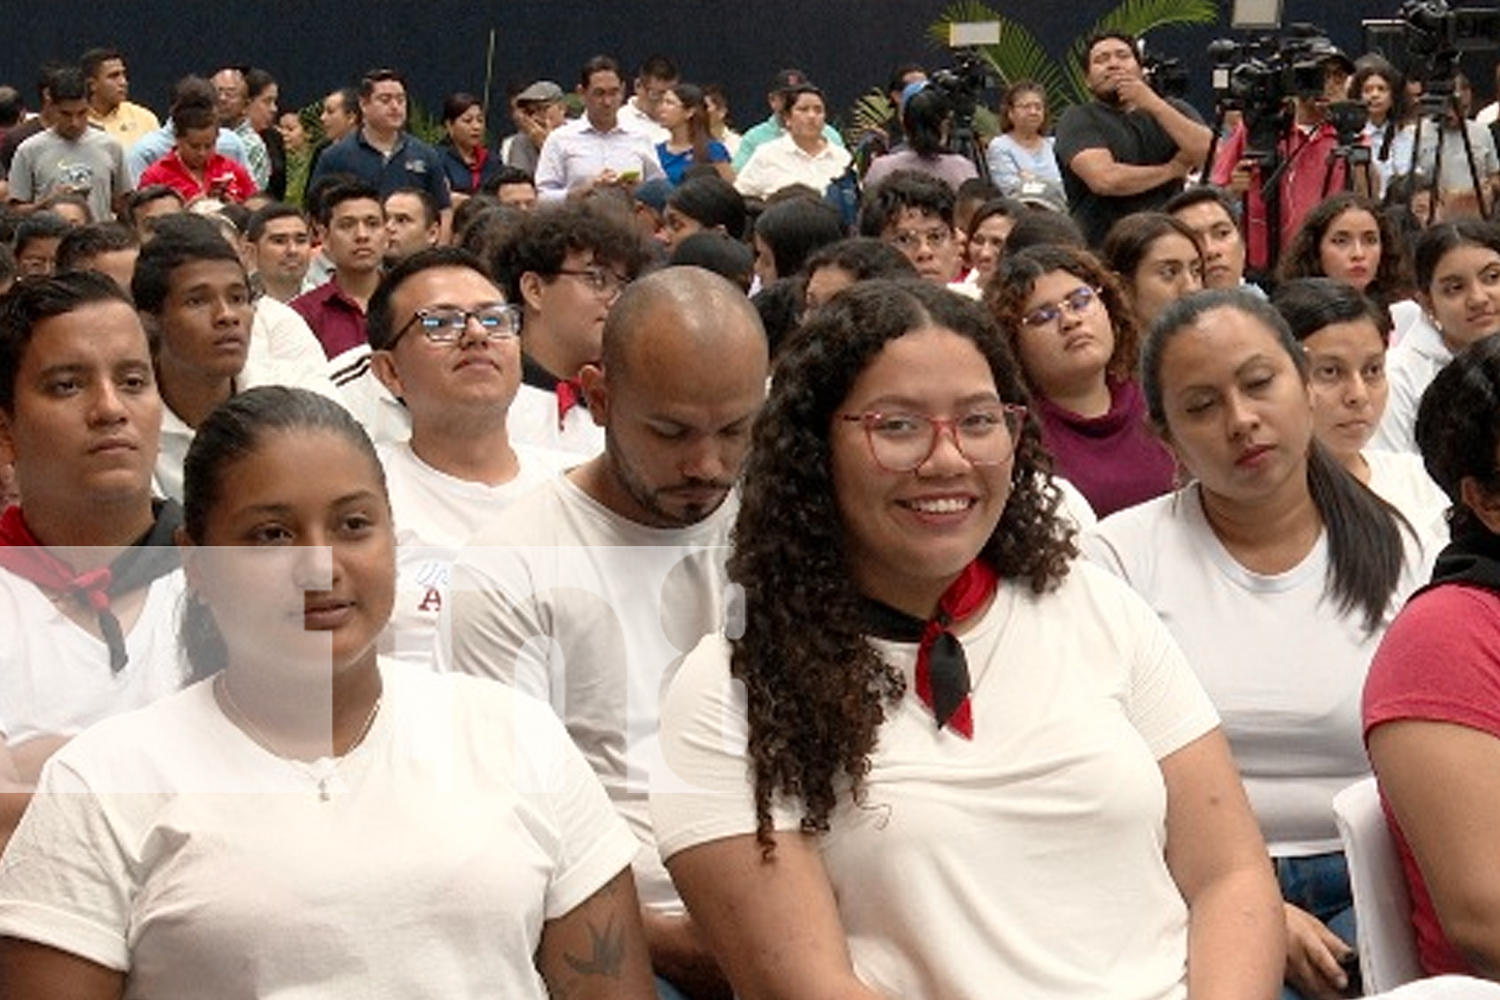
1334 778 1422 994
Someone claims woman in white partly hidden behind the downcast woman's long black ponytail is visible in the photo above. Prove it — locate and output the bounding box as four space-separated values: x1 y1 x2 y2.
1271 277 1448 539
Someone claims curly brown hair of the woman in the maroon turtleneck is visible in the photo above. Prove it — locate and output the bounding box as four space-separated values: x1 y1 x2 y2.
984 244 1140 391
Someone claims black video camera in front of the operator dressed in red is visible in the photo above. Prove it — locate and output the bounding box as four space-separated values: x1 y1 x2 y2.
1209 24 1341 160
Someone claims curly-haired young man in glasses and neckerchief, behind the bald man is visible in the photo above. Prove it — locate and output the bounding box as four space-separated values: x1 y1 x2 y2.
491 204 641 456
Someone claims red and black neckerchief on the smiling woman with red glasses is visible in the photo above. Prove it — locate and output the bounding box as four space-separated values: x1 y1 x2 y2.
864 559 1001 739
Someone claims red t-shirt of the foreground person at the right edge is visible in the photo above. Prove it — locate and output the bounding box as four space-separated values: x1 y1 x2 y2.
1364 583 1500 976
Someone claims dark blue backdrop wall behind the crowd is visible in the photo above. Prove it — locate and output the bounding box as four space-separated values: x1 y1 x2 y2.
0 0 1493 138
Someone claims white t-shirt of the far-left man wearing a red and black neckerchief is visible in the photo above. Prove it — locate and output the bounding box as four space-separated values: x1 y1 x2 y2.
0 570 188 745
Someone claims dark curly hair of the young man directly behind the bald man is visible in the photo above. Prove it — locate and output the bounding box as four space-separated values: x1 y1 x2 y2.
491 202 642 303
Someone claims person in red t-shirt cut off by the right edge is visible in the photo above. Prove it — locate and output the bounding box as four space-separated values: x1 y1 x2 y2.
1364 337 1500 979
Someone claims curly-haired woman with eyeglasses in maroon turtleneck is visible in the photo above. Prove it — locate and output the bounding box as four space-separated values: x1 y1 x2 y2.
986 246 1176 517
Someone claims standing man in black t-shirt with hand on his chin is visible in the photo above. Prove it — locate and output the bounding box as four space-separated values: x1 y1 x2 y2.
1056 31 1212 246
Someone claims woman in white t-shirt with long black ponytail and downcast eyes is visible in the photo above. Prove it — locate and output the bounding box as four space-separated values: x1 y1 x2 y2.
1085 289 1431 1000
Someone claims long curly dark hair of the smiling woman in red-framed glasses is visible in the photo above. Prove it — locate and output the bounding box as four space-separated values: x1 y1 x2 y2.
729 279 1077 855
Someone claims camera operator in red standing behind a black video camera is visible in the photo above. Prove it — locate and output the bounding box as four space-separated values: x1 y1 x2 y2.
1212 43 1368 270
